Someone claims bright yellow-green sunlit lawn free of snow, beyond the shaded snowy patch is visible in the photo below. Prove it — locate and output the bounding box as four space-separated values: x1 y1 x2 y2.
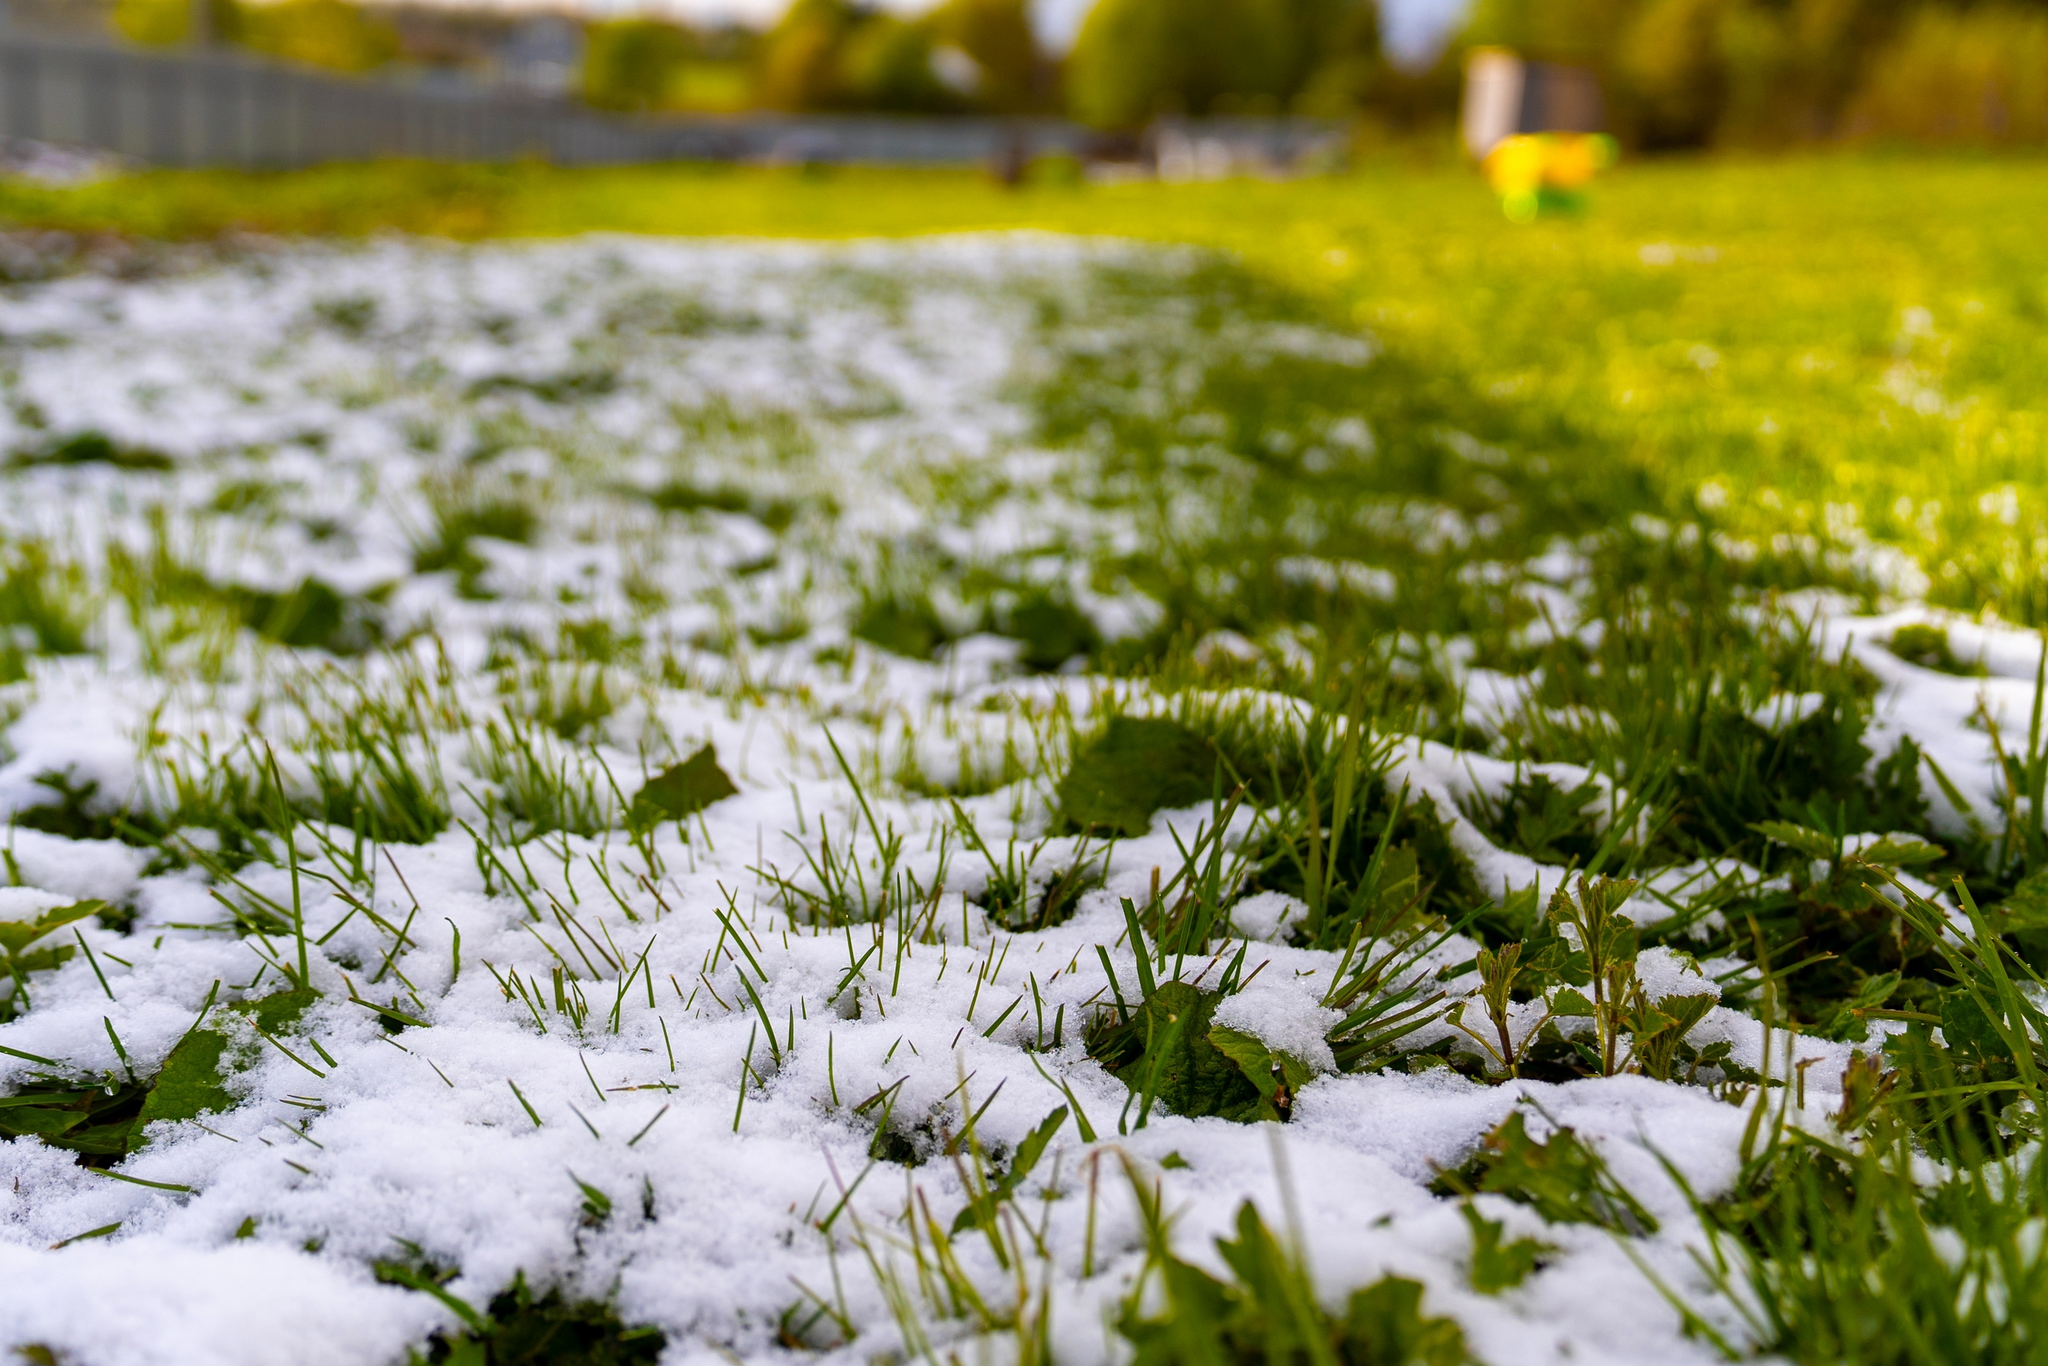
0 156 2048 621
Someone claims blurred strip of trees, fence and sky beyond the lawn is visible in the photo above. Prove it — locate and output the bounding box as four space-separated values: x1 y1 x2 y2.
0 0 2048 168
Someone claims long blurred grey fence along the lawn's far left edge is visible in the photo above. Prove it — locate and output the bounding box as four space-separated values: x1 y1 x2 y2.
0 37 1329 168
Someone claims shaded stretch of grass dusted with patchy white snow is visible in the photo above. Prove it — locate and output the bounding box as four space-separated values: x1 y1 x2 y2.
0 240 2048 1364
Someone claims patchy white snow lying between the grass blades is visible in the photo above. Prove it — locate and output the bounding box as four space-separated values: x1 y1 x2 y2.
0 238 2036 1366
